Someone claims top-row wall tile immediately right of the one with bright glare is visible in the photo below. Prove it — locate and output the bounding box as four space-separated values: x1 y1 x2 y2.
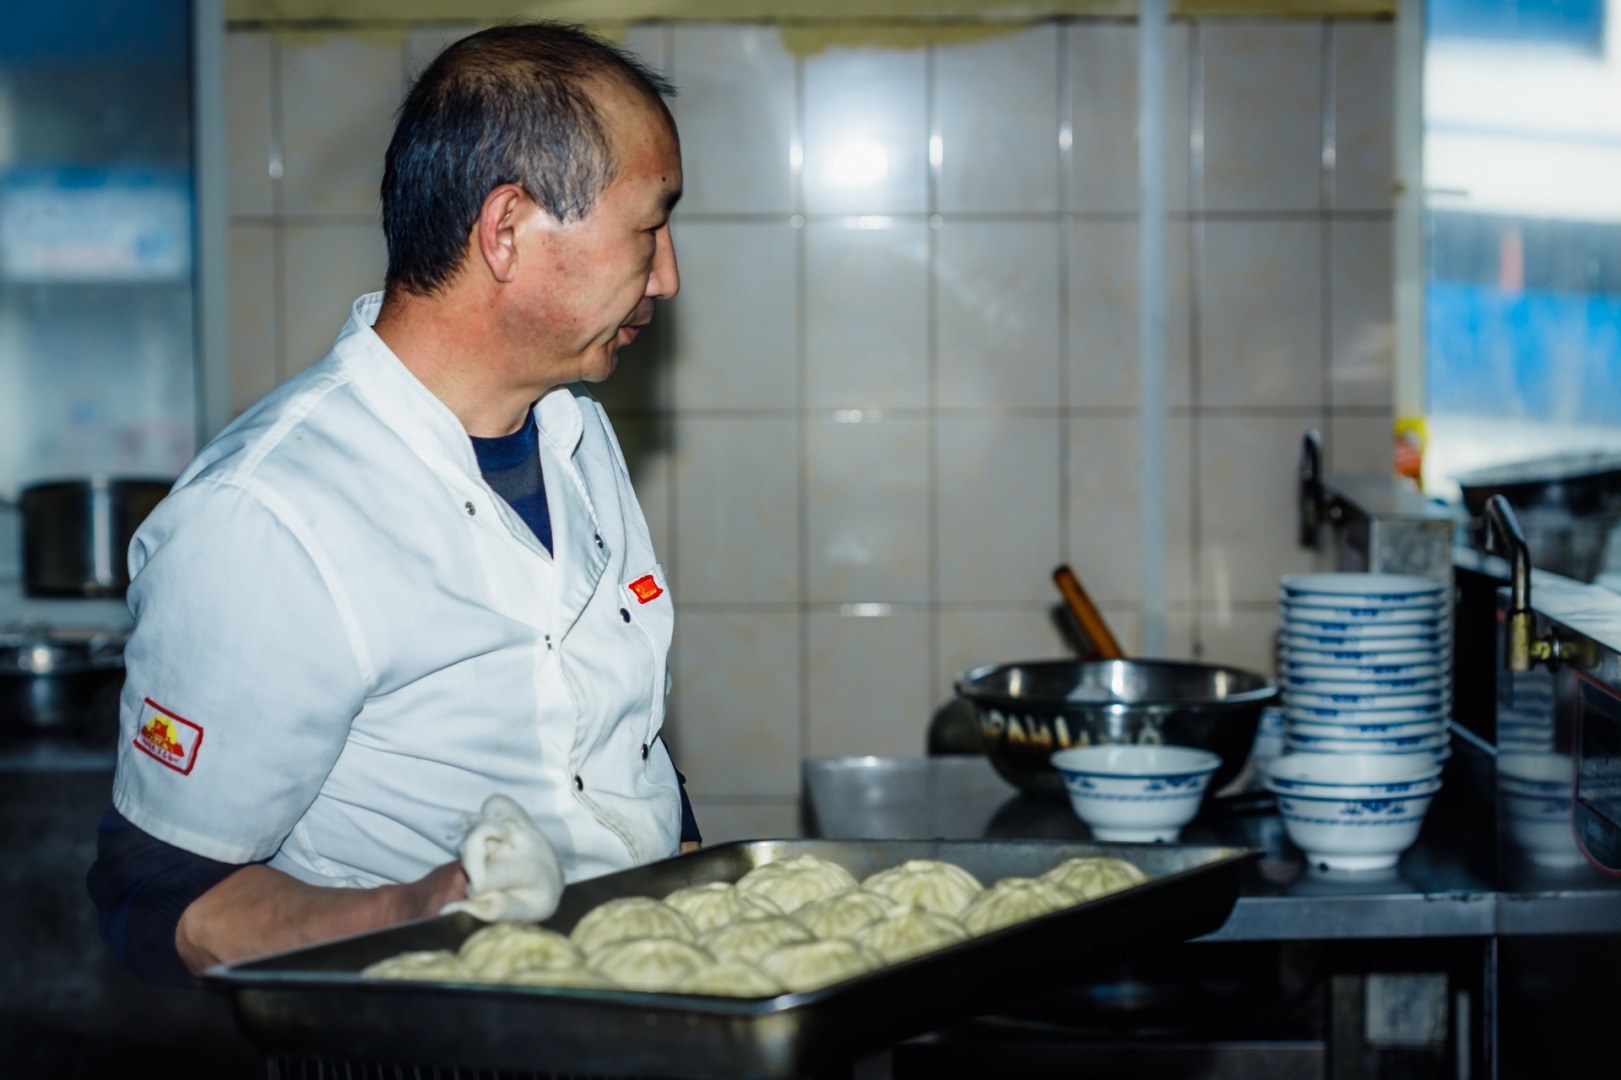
934 23 1059 214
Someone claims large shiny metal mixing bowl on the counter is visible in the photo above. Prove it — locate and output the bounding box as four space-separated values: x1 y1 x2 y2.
956 660 1277 798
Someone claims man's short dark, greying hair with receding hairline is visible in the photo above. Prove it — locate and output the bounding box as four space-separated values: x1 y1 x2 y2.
383 23 676 295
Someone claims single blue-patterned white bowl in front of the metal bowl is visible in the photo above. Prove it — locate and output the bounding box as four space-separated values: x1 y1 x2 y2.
1052 746 1221 843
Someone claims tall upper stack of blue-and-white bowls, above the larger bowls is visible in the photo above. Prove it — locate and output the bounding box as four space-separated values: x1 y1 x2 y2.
1279 574 1452 757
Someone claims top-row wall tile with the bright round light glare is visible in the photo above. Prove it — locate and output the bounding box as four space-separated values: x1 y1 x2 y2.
804 45 929 214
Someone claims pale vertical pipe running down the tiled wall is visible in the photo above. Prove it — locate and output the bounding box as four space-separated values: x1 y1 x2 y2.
1136 0 1169 657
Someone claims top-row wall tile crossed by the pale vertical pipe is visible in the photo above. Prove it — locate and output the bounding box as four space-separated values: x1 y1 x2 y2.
1068 23 1191 212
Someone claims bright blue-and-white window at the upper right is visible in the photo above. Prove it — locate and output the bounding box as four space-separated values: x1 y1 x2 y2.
1423 0 1621 495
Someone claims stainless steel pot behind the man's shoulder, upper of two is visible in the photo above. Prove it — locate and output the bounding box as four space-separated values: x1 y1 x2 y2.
18 477 170 597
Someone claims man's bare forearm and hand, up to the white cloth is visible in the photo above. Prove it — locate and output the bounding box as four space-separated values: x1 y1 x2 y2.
175 863 467 975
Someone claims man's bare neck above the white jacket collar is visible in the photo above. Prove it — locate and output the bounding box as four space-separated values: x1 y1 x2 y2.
371 292 551 438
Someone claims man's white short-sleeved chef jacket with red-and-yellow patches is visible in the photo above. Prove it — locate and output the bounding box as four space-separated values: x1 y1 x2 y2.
113 294 681 887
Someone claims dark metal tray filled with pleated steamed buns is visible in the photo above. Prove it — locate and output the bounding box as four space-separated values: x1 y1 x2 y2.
209 840 1256 1077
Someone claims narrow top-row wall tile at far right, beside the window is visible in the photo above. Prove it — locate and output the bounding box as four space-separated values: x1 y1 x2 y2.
1329 21 1396 209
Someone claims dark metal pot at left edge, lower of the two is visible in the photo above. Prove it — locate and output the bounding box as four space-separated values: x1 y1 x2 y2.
0 634 123 739
